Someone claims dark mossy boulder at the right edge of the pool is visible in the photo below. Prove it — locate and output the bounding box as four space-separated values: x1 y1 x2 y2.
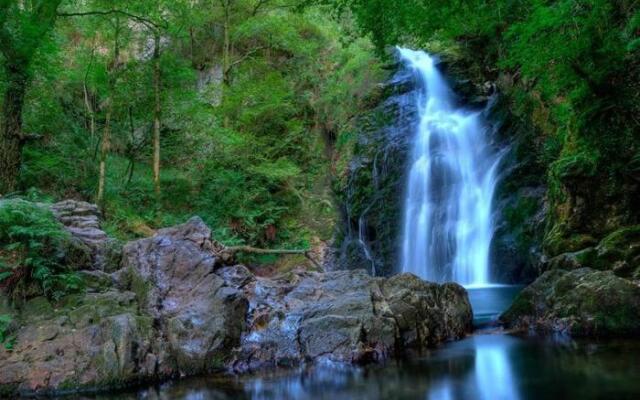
501 268 640 336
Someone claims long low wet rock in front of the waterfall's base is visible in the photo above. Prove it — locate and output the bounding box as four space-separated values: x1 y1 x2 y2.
231 270 472 372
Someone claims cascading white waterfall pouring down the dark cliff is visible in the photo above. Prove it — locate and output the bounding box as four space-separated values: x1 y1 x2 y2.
398 48 499 286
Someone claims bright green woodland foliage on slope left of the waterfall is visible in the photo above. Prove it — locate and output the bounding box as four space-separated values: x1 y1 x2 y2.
0 0 384 262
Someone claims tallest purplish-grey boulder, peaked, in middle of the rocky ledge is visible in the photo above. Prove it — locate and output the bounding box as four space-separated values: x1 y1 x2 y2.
123 218 247 374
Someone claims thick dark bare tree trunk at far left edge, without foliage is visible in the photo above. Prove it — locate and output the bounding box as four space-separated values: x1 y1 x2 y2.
0 65 28 195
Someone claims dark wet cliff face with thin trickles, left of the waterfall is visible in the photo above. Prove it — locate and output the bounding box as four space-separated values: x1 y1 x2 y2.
334 64 418 276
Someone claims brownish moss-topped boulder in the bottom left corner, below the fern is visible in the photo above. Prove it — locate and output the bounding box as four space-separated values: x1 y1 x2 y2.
0 291 156 397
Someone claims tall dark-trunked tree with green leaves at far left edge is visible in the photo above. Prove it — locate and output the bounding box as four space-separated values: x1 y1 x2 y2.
0 0 62 194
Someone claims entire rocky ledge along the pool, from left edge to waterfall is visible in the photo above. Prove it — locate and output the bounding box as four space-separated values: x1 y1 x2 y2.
0 218 472 395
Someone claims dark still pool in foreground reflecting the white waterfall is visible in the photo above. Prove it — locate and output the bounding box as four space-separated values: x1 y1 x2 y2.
75 334 640 400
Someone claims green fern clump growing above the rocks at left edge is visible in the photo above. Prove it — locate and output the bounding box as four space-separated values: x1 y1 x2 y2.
0 199 82 299
